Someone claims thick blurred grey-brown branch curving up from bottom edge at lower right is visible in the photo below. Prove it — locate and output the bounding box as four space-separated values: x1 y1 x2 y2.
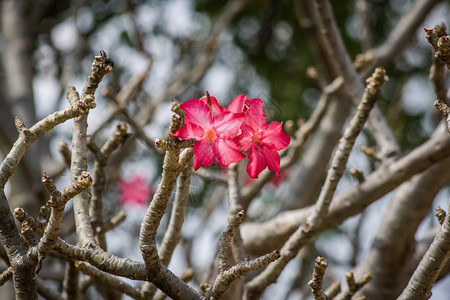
355 154 450 299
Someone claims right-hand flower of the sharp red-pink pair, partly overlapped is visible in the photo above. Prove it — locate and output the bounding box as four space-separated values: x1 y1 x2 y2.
238 98 290 178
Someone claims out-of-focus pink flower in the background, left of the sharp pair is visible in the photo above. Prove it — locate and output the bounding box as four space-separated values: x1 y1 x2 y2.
118 174 153 206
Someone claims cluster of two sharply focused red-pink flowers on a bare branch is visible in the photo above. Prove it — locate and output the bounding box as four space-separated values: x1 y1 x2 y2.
173 92 290 178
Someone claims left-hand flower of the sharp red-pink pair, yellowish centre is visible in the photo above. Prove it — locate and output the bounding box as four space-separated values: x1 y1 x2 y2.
173 93 245 170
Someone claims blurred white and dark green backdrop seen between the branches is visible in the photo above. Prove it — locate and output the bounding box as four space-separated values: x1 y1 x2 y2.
0 0 450 299
